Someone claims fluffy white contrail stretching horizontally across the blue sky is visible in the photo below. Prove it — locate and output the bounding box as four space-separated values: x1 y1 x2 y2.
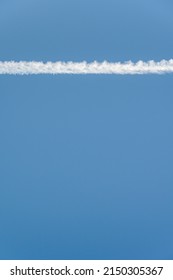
0 59 173 75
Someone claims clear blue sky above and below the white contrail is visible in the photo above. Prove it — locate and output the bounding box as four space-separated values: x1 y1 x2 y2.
0 0 173 259
